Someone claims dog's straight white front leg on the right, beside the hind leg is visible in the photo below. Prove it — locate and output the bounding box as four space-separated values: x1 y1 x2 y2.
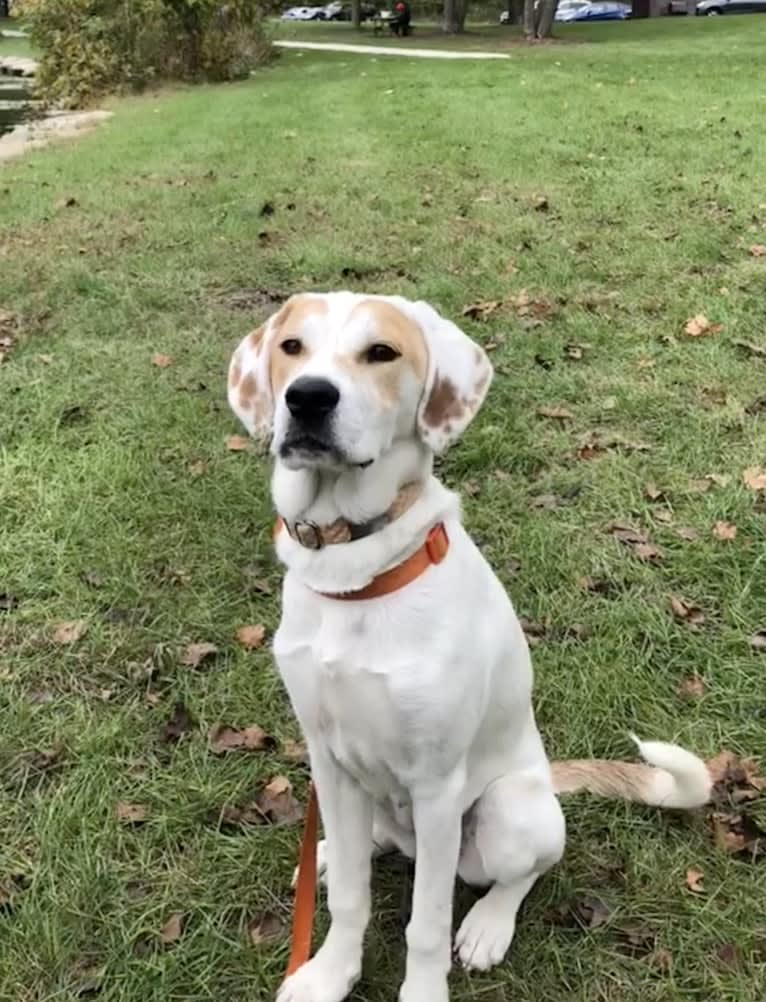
399 770 463 1002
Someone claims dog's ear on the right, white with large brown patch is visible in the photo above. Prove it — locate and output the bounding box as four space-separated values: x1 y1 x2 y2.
412 303 492 453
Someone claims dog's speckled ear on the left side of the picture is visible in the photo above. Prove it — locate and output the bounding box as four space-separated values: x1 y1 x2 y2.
229 318 274 439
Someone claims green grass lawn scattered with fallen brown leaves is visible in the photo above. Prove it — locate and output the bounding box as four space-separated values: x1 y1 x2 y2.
0 17 766 1002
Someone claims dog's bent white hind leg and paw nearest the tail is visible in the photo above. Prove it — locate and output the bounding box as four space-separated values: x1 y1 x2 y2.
455 774 565 971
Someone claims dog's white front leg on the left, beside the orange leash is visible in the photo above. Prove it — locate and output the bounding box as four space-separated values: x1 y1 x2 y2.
277 740 373 1002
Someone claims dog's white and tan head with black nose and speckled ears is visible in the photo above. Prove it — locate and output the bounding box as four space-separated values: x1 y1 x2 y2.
229 293 492 469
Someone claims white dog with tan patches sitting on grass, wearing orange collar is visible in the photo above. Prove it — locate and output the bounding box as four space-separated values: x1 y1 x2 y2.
229 293 711 1002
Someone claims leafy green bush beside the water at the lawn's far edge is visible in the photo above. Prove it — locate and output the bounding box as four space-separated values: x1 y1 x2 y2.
14 0 271 107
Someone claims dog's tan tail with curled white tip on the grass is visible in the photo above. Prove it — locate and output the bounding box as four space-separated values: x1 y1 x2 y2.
551 735 713 810
